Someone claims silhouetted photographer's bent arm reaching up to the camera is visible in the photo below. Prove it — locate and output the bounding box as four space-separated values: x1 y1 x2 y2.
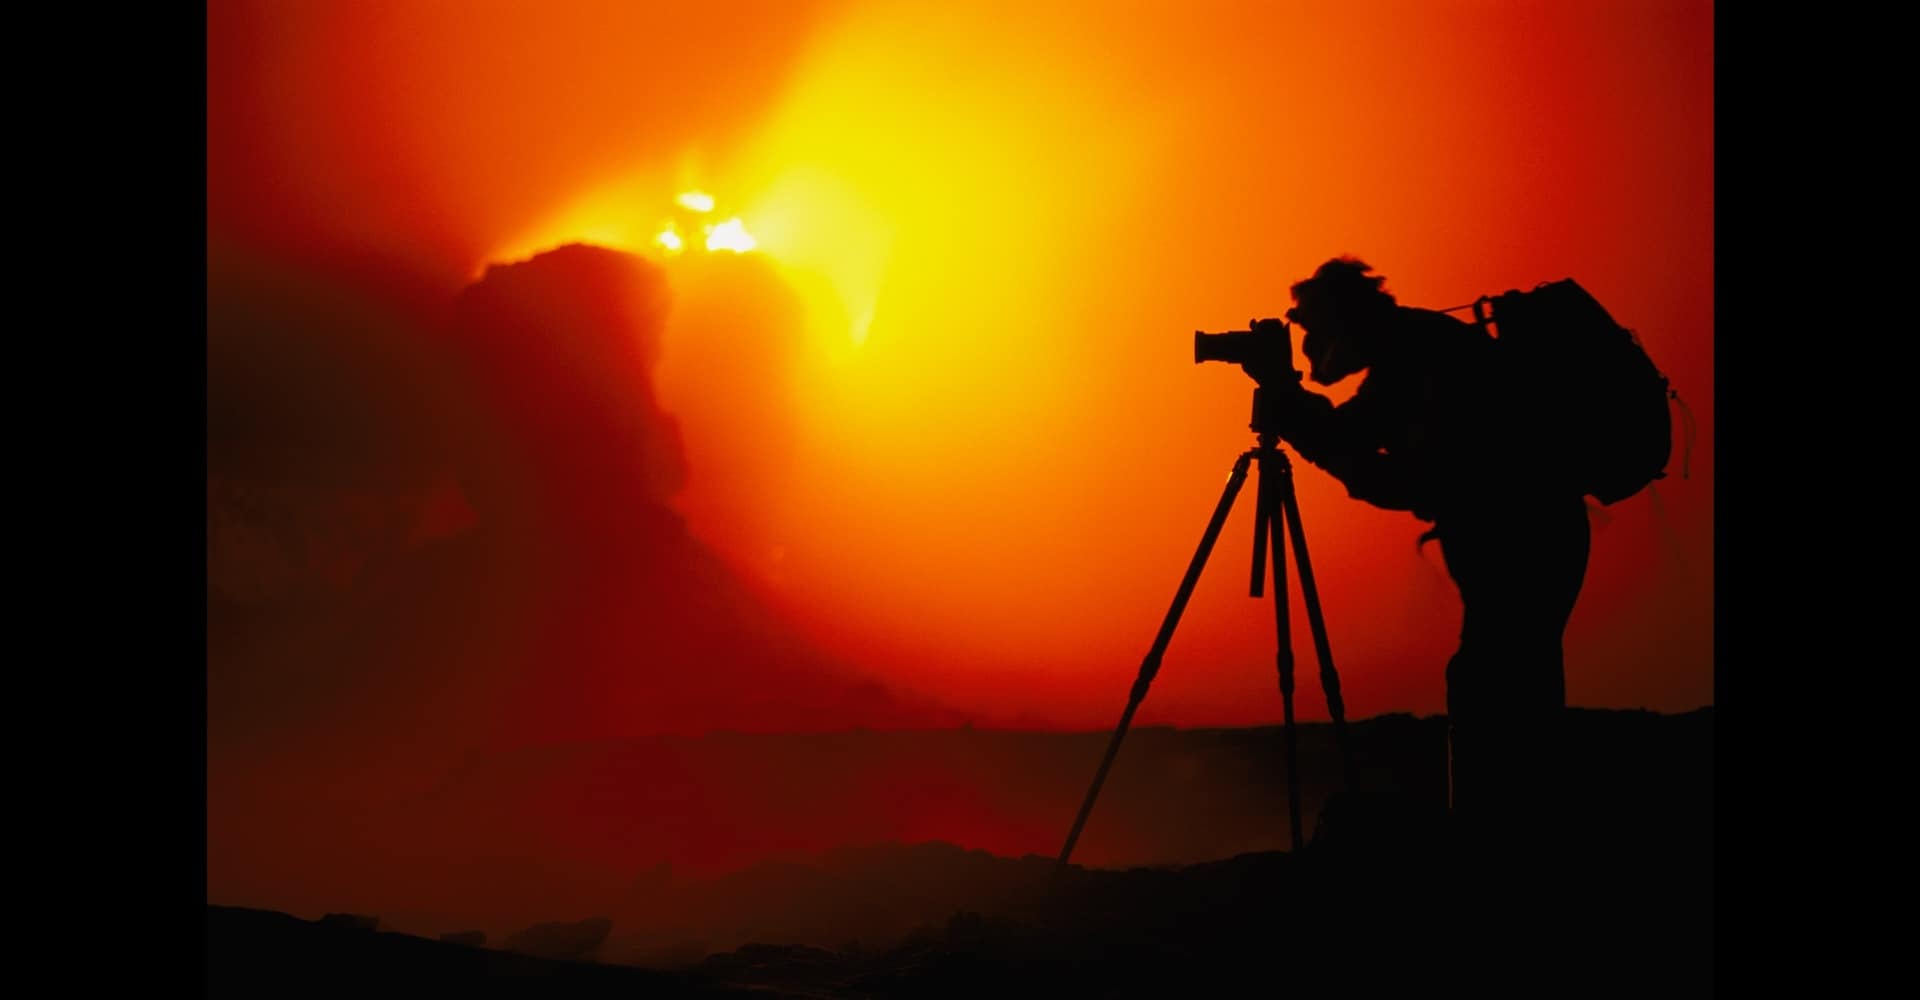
1269 382 1415 511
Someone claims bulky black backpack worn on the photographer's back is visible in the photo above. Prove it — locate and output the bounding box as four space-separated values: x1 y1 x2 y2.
1473 278 1678 505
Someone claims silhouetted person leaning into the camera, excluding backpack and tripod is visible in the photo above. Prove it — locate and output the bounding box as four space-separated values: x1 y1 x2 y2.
1235 257 1588 846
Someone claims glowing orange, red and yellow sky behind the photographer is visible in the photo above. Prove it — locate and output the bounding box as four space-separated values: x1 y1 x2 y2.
207 0 1715 727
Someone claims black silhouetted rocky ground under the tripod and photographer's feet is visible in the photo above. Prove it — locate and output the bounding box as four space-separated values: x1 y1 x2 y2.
687 817 1713 998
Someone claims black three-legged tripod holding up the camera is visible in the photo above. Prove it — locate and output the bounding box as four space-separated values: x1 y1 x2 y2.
1056 388 1354 871
